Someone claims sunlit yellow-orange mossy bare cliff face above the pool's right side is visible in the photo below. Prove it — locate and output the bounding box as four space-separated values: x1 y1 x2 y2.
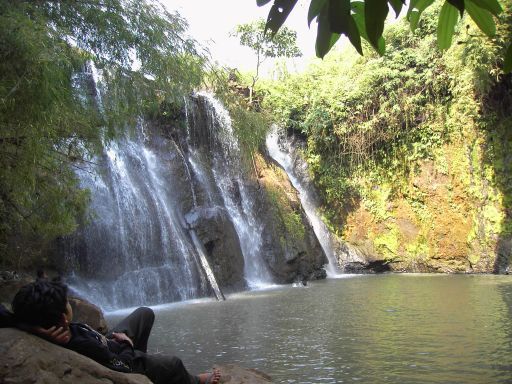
341 130 510 272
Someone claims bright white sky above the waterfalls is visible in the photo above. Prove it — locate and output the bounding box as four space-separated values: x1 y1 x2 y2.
162 0 316 74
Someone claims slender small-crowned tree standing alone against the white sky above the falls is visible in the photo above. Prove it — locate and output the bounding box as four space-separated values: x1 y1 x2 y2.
232 19 302 103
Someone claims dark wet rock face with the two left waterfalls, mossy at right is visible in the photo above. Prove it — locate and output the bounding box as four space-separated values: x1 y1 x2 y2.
56 95 327 309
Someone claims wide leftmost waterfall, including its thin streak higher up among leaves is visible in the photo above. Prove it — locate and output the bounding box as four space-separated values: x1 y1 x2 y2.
61 63 231 309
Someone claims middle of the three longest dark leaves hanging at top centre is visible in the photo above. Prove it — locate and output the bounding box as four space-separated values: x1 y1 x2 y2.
326 0 363 55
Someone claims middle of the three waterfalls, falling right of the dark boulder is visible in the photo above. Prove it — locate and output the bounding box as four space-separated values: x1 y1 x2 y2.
183 93 272 288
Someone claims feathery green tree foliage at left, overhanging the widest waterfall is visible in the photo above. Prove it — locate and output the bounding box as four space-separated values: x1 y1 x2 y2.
0 0 204 267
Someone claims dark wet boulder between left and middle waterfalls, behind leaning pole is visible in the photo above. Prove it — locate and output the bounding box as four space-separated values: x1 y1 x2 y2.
185 207 245 292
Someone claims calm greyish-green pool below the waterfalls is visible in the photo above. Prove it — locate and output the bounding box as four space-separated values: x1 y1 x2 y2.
107 275 512 384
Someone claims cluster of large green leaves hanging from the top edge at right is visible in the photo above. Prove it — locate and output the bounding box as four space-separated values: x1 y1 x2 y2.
256 0 512 72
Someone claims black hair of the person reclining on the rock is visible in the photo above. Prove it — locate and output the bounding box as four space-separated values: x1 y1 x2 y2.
12 280 68 328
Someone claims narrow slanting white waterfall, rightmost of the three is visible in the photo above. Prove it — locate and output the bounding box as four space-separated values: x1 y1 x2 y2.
266 126 340 277
